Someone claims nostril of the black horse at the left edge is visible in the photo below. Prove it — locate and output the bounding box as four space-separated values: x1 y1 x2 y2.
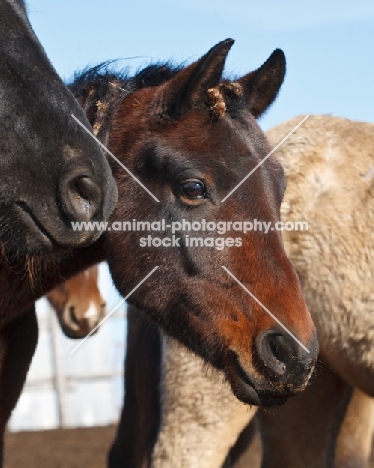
60 173 103 221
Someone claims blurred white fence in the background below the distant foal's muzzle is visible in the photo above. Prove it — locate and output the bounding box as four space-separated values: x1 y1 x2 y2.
9 264 126 431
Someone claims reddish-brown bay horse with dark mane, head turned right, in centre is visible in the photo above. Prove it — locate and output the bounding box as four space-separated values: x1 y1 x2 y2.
0 39 318 464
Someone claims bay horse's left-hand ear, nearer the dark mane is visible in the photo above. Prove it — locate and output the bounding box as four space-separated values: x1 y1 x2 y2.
156 39 234 118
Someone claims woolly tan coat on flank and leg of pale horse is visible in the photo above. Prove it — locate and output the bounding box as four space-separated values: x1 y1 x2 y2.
152 116 374 468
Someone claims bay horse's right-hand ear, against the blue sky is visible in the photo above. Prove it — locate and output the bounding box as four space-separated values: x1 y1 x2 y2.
238 49 286 118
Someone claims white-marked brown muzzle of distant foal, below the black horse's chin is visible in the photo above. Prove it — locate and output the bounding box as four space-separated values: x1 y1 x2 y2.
46 265 106 339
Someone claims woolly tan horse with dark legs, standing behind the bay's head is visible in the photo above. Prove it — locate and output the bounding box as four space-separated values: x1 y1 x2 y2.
109 116 374 468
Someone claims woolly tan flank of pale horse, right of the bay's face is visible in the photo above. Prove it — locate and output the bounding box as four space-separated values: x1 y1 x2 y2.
274 116 374 396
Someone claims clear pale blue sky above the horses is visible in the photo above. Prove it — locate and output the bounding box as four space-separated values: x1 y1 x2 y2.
27 0 374 129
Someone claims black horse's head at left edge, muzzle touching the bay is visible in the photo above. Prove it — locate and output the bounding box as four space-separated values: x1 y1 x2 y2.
0 0 117 255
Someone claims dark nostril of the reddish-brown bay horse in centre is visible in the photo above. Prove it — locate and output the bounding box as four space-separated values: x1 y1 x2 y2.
257 330 296 376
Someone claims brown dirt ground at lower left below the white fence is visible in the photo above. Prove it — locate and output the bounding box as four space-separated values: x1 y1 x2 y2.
4 426 374 468
